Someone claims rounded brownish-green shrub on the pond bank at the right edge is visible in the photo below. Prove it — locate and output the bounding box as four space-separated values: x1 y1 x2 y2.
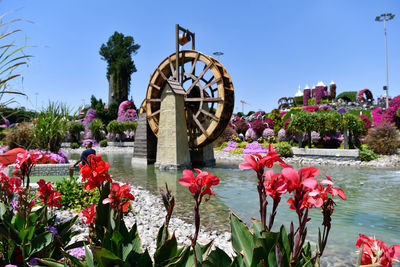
365 121 399 155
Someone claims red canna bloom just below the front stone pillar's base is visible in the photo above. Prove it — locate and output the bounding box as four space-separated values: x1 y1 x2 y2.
179 169 219 201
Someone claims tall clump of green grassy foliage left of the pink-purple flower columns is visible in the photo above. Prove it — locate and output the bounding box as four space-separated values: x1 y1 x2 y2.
34 102 69 153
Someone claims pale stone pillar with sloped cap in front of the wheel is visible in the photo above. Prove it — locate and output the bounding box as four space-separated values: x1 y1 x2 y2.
155 80 191 169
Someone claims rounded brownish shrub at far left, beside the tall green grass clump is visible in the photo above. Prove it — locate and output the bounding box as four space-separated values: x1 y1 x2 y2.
5 123 37 149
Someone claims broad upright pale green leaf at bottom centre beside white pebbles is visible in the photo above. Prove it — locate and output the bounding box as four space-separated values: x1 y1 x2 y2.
230 212 255 266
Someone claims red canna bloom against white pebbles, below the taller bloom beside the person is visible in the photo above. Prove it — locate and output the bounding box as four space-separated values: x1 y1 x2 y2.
103 183 135 212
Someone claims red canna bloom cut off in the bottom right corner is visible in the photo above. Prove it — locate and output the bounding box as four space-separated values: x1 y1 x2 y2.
356 234 400 267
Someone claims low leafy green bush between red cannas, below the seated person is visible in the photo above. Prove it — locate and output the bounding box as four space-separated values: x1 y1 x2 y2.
55 177 100 212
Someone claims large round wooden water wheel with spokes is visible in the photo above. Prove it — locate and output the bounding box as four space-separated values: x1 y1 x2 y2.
145 50 234 148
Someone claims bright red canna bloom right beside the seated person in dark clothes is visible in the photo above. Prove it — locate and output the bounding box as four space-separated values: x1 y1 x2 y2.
79 155 111 191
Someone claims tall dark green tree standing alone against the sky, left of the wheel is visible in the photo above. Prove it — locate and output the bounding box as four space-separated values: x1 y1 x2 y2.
99 32 140 105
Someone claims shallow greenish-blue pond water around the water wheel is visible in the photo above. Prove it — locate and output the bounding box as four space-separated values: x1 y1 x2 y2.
71 154 400 263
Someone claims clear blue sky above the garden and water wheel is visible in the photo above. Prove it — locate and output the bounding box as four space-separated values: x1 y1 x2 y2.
0 0 400 112
